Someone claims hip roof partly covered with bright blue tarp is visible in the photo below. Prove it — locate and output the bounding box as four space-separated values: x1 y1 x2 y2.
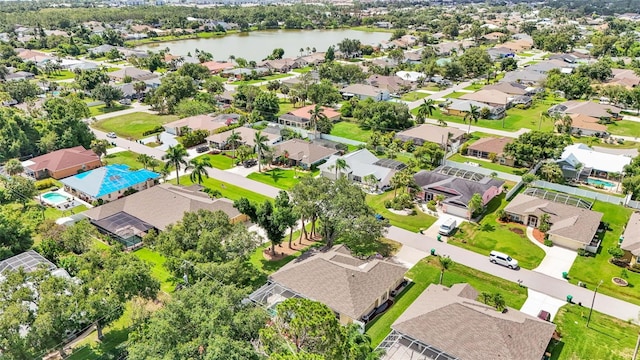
61 164 160 198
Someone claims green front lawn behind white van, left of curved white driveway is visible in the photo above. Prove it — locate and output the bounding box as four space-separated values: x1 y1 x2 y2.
449 194 545 269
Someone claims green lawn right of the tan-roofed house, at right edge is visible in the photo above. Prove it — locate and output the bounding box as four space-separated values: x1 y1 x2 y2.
569 201 640 305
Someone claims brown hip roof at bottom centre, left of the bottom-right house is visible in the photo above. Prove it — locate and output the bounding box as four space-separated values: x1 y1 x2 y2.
270 245 406 319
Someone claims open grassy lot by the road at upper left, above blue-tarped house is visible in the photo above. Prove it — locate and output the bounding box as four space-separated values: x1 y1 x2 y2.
93 112 178 139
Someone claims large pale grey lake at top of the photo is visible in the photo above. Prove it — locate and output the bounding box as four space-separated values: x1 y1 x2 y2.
136 29 391 61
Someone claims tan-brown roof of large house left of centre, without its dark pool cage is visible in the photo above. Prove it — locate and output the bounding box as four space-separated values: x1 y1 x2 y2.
83 183 240 230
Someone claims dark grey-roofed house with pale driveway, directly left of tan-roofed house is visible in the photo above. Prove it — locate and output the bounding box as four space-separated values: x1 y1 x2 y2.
413 166 504 218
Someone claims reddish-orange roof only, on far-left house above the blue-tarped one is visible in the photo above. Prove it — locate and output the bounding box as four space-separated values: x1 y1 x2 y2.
25 146 100 172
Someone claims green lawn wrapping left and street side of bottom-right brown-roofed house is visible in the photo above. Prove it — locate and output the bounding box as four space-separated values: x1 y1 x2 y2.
367 256 527 346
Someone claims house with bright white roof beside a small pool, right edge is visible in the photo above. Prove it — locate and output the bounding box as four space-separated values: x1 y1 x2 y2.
556 144 632 182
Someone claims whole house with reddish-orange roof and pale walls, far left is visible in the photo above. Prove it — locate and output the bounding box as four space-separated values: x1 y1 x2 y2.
22 146 102 180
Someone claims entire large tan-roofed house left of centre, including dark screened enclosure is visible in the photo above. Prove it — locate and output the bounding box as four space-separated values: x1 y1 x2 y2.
82 183 247 245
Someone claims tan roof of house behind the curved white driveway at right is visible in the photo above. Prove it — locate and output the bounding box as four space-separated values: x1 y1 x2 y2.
504 194 603 244
